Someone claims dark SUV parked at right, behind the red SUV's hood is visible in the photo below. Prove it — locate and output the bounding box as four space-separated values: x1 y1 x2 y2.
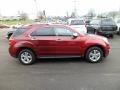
87 18 117 37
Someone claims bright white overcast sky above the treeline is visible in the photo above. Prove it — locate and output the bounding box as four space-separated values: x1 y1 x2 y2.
0 0 120 17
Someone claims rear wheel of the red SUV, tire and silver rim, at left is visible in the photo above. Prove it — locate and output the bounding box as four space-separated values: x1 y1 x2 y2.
18 49 36 65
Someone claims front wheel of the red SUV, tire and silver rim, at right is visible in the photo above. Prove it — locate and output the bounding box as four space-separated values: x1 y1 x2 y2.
85 47 103 63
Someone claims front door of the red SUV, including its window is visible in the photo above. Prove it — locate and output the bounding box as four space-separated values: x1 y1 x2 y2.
54 27 81 55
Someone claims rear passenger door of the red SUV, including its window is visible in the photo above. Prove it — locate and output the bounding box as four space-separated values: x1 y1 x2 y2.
31 27 56 56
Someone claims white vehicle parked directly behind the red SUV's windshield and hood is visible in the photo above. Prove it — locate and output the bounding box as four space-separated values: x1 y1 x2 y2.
68 19 87 34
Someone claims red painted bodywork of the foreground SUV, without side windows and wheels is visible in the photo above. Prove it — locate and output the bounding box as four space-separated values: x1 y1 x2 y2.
9 24 110 57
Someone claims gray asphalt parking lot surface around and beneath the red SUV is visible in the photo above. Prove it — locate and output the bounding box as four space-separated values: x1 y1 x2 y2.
0 29 120 90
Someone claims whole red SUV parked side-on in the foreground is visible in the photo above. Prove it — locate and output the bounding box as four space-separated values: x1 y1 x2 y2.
9 24 110 65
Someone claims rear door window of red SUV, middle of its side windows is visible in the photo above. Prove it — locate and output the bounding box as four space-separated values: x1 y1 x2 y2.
31 27 55 36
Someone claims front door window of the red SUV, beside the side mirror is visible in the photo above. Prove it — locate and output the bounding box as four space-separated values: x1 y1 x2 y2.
54 27 73 36
